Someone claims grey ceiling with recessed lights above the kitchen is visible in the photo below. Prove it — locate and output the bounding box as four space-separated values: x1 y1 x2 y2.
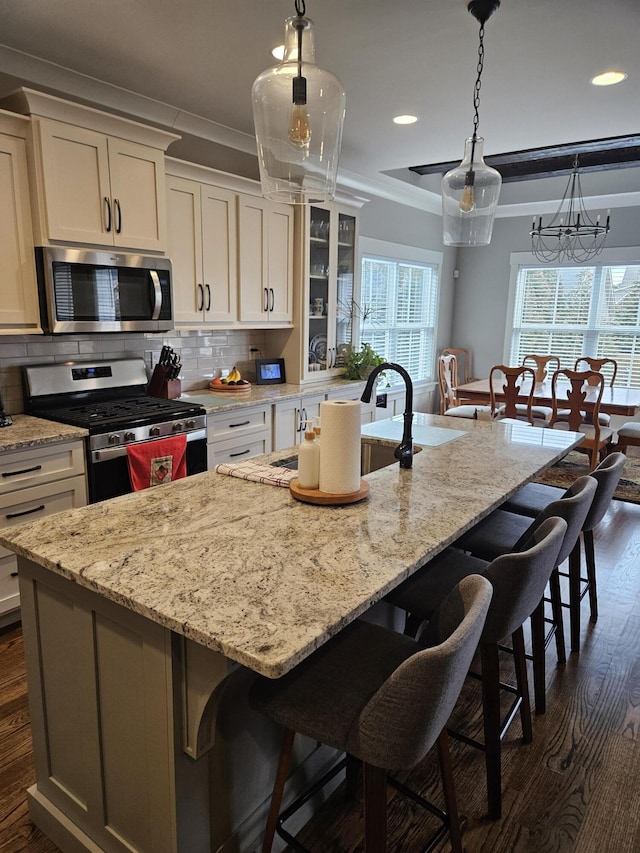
0 0 640 215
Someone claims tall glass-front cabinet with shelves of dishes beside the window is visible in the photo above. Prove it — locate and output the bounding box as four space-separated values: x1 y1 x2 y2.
304 207 356 378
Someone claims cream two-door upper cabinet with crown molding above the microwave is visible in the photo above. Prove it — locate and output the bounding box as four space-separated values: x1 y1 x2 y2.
4 89 178 252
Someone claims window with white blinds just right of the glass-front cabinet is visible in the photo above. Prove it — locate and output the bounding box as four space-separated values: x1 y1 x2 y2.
358 238 442 382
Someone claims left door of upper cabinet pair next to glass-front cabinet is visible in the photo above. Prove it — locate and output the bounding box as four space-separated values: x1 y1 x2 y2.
238 196 270 323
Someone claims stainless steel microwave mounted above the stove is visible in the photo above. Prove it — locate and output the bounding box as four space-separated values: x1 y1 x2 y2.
36 246 173 334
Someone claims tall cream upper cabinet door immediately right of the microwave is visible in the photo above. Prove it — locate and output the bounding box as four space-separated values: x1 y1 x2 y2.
167 177 204 323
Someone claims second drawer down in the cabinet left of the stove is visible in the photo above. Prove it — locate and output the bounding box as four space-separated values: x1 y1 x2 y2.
0 475 87 557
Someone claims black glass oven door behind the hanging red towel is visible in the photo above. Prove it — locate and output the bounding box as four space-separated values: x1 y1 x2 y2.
88 429 207 503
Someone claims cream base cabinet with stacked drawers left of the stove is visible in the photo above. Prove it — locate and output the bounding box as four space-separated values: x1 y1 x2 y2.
0 441 87 626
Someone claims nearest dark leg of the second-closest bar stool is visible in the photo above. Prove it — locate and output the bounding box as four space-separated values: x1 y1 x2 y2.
480 643 502 820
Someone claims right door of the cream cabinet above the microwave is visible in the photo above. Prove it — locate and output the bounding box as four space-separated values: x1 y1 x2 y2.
108 137 166 251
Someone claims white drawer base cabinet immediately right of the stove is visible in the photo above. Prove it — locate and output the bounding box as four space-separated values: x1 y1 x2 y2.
207 404 271 470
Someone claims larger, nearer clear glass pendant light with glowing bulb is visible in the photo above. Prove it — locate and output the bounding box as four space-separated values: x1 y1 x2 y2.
251 0 345 204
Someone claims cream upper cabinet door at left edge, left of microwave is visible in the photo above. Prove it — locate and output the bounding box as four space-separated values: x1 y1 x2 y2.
0 134 41 334
